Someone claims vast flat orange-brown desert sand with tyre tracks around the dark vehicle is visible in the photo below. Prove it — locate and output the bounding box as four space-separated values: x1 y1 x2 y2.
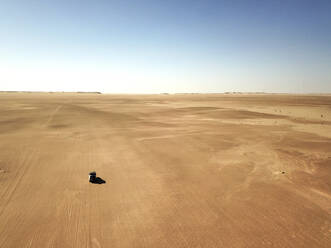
0 93 331 248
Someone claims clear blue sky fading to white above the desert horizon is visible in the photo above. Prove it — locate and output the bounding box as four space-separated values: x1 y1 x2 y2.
0 0 331 93
